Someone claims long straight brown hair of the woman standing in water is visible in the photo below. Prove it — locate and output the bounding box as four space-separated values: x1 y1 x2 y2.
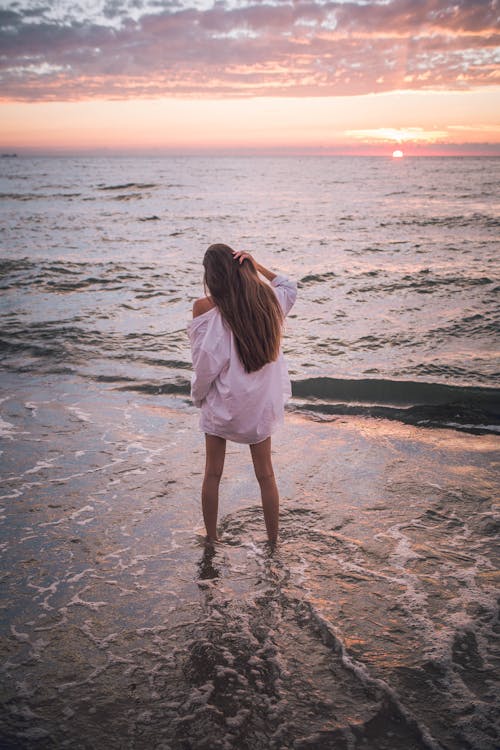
203 244 283 372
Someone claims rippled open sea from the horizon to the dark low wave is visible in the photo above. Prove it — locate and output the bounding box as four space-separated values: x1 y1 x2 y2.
0 157 500 412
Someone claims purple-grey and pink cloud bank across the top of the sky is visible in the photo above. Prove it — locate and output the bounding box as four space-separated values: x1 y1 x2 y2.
0 0 500 101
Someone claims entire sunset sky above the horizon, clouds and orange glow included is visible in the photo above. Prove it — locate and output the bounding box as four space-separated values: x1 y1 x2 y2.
0 0 500 155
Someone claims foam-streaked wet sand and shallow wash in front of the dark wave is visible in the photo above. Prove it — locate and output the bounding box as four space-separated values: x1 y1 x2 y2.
0 376 500 750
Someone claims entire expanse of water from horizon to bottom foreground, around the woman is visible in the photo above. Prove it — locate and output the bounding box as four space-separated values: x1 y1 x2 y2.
0 156 500 750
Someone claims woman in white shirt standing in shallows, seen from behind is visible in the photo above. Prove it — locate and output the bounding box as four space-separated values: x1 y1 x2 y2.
188 244 297 545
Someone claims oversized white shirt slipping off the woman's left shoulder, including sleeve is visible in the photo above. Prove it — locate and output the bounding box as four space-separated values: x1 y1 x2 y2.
188 275 297 444
